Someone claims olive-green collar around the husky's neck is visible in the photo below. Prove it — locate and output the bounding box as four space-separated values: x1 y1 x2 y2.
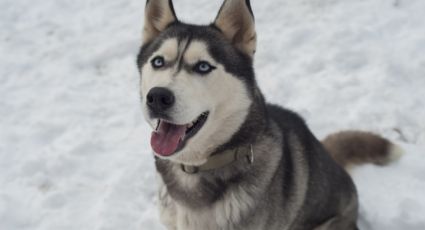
181 145 254 174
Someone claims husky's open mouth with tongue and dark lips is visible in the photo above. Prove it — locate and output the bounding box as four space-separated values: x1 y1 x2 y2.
151 112 209 157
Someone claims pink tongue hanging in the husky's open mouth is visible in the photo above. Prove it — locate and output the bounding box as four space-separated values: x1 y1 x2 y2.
151 121 186 156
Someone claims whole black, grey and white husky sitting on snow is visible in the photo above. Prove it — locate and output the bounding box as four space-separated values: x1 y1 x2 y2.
137 0 401 230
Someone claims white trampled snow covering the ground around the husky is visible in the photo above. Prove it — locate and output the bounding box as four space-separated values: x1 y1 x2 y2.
0 0 425 230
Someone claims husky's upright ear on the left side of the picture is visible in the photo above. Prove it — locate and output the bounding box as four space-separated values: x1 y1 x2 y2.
143 0 177 44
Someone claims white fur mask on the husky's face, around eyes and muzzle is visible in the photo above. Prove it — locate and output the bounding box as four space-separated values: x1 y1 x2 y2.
141 38 251 165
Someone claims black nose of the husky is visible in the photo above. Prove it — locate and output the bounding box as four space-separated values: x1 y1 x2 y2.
146 87 175 112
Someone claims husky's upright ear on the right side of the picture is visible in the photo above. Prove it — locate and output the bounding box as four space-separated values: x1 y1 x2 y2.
214 0 253 57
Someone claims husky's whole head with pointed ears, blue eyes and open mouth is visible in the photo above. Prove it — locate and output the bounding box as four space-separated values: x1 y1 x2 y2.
138 0 255 165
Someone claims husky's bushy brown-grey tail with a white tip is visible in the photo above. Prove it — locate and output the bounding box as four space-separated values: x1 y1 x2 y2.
322 131 403 170
